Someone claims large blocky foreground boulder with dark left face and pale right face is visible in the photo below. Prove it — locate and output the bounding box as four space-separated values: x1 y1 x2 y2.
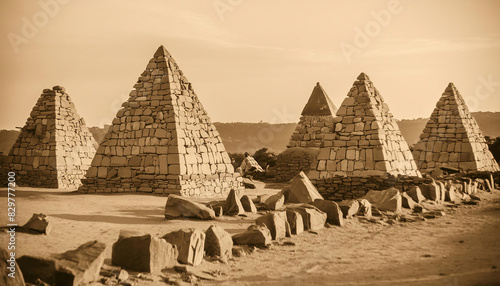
111 231 178 273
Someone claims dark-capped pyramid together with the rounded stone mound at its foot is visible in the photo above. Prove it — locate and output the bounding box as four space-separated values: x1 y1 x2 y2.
276 82 337 181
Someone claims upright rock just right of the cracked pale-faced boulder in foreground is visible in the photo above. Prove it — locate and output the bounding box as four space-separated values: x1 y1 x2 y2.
205 225 233 261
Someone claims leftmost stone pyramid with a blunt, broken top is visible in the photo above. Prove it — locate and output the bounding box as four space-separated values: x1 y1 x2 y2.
3 86 97 189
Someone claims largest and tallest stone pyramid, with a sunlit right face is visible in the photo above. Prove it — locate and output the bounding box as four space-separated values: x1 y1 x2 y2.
80 46 241 197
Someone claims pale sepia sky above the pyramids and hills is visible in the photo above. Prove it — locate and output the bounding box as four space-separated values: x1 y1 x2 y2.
0 0 500 129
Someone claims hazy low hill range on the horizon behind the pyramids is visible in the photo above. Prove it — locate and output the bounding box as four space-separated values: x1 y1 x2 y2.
0 112 500 154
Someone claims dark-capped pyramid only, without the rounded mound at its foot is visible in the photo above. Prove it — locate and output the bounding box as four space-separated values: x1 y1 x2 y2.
288 82 337 148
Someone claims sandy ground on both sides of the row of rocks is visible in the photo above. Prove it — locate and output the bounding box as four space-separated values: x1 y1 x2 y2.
0 183 500 286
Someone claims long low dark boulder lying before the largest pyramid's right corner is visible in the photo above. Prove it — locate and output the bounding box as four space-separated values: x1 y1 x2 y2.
165 194 215 220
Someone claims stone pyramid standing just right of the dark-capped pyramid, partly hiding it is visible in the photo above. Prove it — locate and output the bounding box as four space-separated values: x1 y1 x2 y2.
309 73 420 180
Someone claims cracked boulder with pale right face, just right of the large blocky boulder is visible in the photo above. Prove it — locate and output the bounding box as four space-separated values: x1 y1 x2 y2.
163 228 205 266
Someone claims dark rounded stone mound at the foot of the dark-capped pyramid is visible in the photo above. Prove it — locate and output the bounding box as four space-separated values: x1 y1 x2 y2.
274 147 319 182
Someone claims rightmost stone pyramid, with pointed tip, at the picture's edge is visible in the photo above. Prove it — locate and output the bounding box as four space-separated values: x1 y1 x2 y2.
413 83 500 172
